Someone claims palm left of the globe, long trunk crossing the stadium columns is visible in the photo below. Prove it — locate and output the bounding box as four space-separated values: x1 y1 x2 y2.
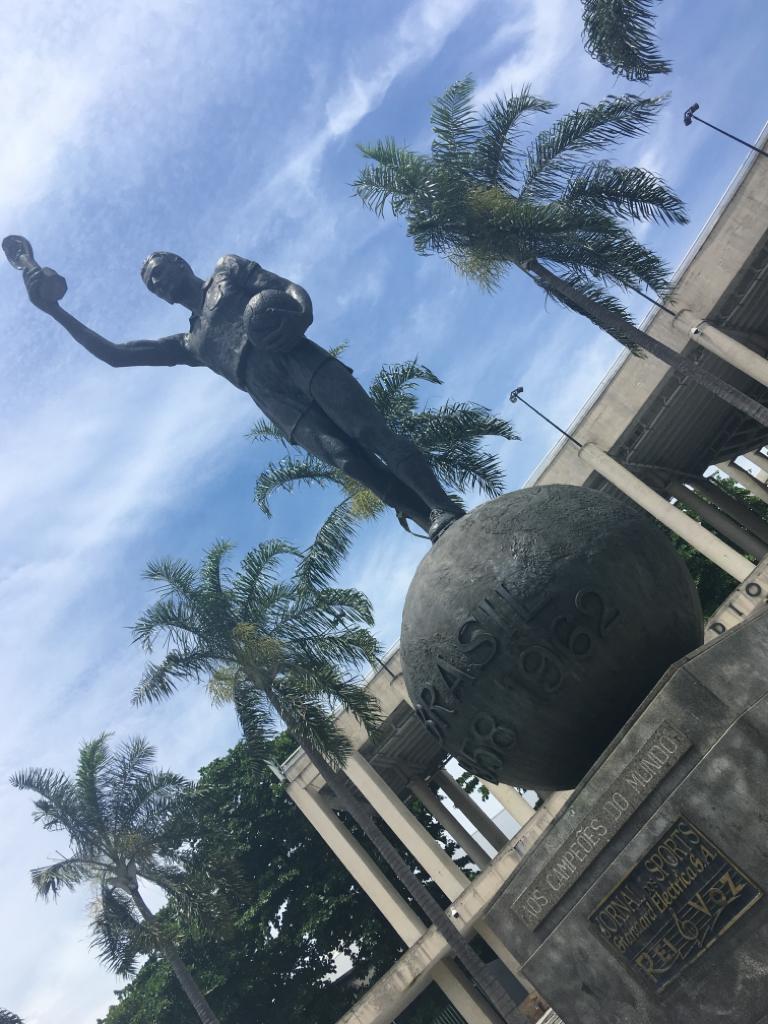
133 538 519 1024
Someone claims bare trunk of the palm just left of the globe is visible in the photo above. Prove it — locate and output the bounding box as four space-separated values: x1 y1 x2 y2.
292 741 524 1024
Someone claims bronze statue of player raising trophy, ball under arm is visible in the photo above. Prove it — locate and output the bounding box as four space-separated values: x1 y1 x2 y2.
10 245 461 539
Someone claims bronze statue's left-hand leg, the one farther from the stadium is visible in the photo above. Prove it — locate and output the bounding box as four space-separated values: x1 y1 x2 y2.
292 401 430 530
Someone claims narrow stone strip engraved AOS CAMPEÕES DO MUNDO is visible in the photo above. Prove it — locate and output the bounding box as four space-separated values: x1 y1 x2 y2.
513 722 690 929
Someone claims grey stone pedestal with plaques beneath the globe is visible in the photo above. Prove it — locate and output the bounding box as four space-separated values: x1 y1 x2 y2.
488 610 768 1024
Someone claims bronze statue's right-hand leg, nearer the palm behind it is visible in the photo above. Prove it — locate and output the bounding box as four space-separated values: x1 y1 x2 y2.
311 359 462 516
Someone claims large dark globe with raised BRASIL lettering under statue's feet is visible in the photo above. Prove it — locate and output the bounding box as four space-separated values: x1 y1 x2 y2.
400 484 703 790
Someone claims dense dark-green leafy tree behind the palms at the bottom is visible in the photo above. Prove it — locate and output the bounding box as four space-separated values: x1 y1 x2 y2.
103 733 451 1024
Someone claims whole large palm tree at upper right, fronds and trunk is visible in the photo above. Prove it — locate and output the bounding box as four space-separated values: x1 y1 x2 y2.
354 78 768 426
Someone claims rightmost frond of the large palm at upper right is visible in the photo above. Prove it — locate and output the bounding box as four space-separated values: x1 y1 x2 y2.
562 161 688 224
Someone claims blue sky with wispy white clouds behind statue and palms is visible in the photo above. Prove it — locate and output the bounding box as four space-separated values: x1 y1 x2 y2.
0 0 768 1024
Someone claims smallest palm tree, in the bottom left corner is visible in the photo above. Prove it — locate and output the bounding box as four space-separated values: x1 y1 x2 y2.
10 733 218 1024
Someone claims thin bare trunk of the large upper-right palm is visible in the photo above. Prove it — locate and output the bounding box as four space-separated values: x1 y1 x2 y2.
525 260 768 427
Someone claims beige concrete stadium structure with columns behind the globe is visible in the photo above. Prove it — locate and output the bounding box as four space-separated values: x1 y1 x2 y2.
282 121 768 1024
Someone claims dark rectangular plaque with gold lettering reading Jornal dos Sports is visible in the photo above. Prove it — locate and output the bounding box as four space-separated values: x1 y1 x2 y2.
589 817 763 992
